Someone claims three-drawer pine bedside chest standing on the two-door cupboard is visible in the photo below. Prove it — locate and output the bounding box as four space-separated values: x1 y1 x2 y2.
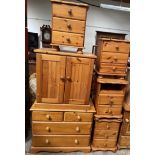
51 0 88 48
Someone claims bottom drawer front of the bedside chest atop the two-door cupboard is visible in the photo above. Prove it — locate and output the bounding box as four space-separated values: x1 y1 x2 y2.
52 31 84 47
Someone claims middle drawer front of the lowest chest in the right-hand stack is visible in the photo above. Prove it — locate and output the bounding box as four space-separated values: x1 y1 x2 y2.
94 130 118 139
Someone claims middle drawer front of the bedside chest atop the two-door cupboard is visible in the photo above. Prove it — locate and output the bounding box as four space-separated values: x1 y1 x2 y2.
52 17 85 34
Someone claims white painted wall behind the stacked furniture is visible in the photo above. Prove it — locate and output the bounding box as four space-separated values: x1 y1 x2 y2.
28 0 130 52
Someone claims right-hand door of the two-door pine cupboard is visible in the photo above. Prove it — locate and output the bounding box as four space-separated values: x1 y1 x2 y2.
64 56 94 104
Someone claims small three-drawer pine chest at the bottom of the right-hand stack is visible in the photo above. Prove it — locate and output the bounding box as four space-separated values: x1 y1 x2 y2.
92 117 122 151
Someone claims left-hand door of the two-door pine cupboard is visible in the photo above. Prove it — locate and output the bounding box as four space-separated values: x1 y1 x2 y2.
37 54 66 103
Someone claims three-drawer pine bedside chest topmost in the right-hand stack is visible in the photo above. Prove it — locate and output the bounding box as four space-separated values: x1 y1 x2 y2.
96 38 130 76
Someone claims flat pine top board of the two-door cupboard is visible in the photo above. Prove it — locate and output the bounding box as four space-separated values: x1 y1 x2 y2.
34 48 97 59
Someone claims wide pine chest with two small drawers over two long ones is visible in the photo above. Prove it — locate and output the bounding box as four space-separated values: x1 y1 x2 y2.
31 100 95 153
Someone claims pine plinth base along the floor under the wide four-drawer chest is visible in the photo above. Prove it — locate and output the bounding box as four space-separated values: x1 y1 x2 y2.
31 146 91 153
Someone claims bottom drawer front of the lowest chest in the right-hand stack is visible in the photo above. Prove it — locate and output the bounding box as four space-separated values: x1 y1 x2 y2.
93 139 117 148
